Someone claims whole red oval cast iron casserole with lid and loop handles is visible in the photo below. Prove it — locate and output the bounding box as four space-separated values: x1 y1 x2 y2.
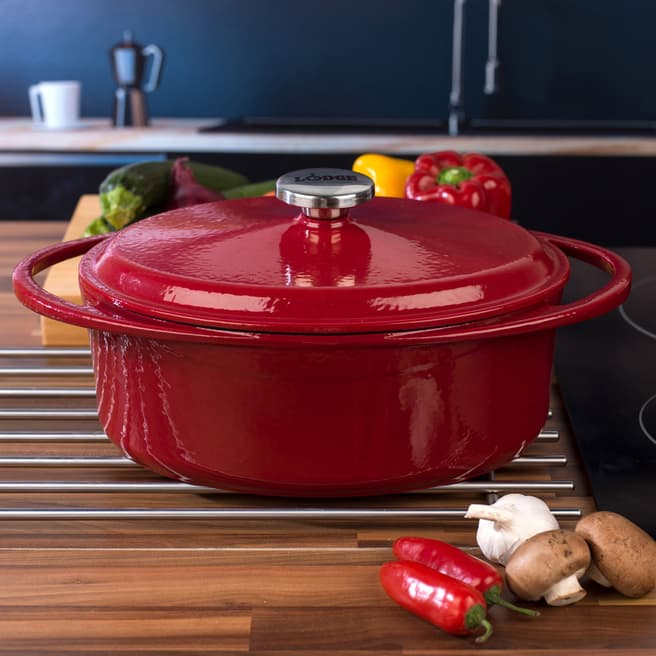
14 169 631 496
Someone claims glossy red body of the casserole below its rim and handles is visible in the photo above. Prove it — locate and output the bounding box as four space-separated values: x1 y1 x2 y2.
91 331 553 496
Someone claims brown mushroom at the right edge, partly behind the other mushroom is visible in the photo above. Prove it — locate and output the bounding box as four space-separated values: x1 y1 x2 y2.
575 511 656 597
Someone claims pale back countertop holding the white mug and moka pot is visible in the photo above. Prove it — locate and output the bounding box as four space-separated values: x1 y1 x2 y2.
0 118 656 157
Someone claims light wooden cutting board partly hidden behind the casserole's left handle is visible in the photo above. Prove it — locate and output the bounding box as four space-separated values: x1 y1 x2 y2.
41 194 101 346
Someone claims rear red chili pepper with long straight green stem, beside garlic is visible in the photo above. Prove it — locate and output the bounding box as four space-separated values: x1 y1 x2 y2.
392 537 540 617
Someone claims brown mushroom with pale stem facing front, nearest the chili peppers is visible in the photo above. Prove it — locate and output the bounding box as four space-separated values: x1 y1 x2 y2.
506 529 590 606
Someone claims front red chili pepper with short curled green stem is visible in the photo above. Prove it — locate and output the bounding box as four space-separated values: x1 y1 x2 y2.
380 560 492 642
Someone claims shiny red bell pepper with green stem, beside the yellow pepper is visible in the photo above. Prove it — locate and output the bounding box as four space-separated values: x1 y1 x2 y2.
405 150 511 219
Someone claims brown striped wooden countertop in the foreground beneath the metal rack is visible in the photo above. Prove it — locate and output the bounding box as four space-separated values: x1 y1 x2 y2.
0 222 656 656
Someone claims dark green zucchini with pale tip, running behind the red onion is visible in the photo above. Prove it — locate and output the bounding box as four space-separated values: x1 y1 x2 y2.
100 160 248 230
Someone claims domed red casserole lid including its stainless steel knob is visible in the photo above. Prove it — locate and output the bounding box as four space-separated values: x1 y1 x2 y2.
80 169 569 333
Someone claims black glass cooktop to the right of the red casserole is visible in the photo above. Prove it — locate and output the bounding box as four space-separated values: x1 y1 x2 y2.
555 248 656 537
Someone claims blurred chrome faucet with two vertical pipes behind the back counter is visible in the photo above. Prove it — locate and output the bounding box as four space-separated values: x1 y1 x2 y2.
448 0 501 136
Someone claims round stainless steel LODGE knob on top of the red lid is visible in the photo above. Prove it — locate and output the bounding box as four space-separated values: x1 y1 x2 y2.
276 168 374 219
